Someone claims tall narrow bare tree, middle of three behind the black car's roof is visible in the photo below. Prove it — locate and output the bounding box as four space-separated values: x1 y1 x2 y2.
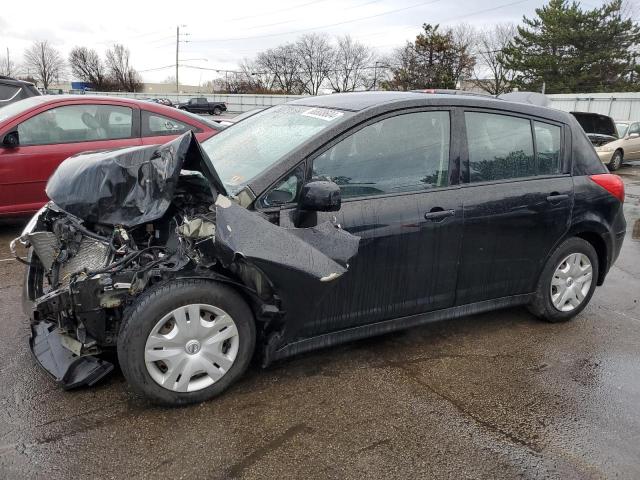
296 33 334 95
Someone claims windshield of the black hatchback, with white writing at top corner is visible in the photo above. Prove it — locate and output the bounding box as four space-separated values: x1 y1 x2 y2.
202 105 349 194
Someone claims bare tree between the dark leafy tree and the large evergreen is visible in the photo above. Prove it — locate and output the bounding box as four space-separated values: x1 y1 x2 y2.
474 23 518 95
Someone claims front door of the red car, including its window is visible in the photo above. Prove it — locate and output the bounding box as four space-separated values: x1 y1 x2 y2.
0 104 140 214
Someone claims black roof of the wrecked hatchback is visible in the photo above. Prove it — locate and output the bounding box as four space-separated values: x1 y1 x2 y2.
288 91 569 123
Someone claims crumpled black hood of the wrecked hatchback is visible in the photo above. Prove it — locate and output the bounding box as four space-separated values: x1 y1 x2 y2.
46 132 226 226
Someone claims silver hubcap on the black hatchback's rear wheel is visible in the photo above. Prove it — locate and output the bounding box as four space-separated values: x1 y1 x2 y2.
551 253 593 312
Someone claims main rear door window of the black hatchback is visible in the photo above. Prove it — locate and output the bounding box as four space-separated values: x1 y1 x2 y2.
465 112 536 182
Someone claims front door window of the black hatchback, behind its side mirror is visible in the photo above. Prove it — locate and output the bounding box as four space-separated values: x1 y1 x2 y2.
313 112 450 197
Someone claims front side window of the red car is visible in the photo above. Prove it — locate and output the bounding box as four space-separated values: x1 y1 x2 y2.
18 105 133 145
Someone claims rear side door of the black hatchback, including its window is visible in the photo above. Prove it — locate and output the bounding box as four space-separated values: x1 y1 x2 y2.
456 111 573 305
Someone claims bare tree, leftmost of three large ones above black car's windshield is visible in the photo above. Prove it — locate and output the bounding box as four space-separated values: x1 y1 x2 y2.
255 43 302 94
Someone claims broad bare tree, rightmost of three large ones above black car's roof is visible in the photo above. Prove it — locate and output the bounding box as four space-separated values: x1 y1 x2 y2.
328 35 376 92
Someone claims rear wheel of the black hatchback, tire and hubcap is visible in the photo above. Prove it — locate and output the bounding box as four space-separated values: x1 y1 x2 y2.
529 237 598 322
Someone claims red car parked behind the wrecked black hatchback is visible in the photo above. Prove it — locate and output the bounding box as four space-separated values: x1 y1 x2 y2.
0 95 223 217
